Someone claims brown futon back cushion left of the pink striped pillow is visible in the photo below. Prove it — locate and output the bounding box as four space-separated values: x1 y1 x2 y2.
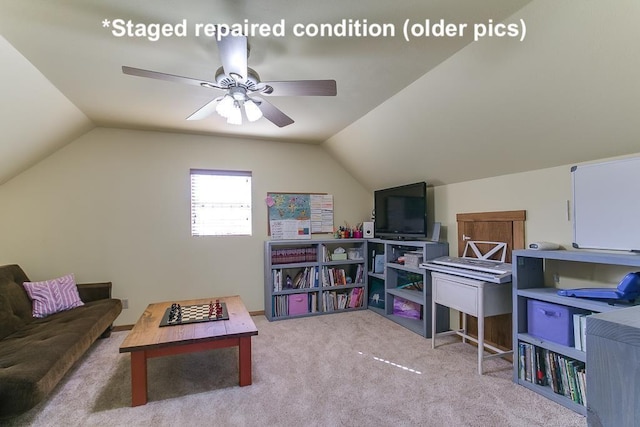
0 264 33 339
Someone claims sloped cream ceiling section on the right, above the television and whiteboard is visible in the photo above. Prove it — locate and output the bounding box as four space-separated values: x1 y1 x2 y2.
325 0 640 191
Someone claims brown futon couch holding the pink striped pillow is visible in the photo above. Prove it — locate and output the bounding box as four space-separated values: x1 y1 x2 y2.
0 265 122 420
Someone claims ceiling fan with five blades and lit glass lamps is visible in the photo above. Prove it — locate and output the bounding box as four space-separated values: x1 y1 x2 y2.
122 35 337 127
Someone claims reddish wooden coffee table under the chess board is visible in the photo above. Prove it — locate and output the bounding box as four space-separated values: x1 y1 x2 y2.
120 295 258 406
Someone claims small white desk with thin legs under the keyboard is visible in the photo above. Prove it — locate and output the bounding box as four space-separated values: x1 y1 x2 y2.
431 272 513 375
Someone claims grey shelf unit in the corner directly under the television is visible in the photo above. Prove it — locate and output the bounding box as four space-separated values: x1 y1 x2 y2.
367 239 449 337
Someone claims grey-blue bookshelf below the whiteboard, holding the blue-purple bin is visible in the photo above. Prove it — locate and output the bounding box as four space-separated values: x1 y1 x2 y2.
512 250 640 415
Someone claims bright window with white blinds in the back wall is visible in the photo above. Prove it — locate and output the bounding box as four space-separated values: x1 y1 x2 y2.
191 169 251 236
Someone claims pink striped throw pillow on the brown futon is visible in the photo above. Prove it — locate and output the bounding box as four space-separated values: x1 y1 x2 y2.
22 274 84 317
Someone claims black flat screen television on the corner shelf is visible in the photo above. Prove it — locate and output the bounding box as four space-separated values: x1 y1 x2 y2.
374 182 427 239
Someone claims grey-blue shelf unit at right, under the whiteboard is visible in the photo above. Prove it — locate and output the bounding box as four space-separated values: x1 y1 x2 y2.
512 249 640 415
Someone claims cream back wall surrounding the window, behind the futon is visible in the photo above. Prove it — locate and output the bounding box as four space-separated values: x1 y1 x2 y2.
0 128 372 325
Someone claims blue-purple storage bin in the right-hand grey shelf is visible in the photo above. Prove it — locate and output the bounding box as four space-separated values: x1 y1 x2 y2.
527 299 589 347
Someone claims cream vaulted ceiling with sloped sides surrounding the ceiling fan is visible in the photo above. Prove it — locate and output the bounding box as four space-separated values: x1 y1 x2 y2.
0 0 640 188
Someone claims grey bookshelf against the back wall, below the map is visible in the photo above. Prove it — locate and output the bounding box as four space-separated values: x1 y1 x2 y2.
264 239 367 321
